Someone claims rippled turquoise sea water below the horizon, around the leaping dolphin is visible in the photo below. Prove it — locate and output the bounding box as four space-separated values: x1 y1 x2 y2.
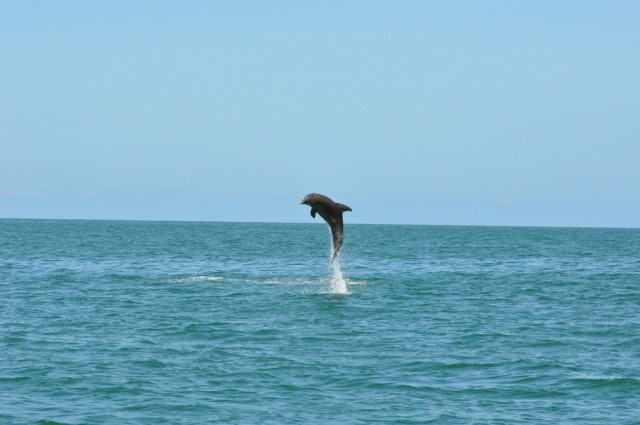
0 220 640 424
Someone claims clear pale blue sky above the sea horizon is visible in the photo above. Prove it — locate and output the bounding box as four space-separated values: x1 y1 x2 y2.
0 0 640 227
